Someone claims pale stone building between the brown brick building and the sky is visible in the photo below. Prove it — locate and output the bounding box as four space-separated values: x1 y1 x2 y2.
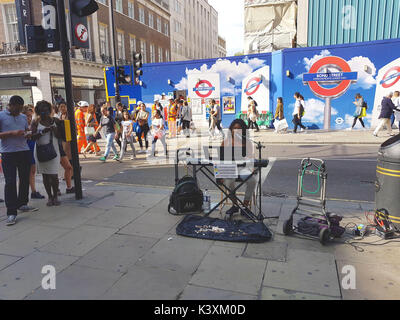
170 0 219 61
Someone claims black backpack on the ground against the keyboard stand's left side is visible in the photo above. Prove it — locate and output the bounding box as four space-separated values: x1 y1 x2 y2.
168 176 203 215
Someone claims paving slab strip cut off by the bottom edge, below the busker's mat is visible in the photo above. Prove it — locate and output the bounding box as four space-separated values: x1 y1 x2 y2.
179 285 257 301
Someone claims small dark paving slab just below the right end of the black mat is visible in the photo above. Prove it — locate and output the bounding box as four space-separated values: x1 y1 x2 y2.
243 241 288 262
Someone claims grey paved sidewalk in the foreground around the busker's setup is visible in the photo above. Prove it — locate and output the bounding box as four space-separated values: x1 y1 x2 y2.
0 183 400 300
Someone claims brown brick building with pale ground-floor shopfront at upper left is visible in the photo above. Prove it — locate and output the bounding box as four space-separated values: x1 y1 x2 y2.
0 0 171 107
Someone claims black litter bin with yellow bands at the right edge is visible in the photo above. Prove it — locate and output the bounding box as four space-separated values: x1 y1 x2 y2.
375 135 400 228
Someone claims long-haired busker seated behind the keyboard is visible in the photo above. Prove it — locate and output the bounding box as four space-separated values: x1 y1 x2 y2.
222 119 257 217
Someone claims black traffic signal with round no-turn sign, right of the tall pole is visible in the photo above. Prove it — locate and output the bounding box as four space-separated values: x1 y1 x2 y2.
69 0 99 49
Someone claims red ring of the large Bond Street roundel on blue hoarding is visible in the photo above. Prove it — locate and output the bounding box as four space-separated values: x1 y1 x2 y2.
308 57 351 98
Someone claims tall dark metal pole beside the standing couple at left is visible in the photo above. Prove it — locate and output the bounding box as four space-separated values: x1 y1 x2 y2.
57 0 83 200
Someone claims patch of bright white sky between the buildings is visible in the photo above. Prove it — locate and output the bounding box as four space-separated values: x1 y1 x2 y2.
208 0 244 56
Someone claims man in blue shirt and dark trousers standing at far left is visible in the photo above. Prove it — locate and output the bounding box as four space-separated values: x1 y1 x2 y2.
0 96 38 226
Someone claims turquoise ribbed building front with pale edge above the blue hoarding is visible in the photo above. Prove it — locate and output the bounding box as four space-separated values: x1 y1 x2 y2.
298 0 400 47
